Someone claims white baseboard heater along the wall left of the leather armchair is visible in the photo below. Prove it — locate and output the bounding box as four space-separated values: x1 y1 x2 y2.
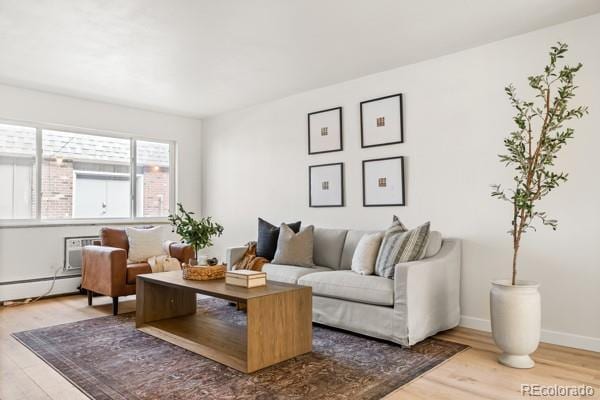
0 276 81 301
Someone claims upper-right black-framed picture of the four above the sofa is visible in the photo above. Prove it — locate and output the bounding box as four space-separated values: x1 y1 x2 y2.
360 93 404 148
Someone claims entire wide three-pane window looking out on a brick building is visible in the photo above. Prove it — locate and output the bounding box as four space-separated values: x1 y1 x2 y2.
0 124 175 221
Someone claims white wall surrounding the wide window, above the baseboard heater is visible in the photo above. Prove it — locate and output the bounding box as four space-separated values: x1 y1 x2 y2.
0 85 201 300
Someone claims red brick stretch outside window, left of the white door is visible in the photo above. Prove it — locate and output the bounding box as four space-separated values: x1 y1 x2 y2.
42 160 73 219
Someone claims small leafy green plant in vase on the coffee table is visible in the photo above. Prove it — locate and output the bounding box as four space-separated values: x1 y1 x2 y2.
169 203 223 265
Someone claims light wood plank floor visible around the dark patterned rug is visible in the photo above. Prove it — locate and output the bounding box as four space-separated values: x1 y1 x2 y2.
0 296 600 400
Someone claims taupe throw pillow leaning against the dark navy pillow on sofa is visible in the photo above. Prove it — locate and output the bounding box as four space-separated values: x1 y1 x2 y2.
271 224 315 267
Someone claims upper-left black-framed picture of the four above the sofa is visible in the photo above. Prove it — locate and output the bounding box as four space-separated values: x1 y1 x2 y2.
308 107 344 154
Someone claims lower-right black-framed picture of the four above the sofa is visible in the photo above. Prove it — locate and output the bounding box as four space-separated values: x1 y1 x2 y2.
363 157 406 207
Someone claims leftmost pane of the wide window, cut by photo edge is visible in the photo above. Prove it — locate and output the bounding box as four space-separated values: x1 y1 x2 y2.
0 124 36 219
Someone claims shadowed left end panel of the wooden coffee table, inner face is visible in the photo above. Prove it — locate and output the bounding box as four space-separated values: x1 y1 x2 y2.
135 277 196 328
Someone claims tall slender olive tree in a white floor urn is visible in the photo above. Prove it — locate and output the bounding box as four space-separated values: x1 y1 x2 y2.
490 42 587 368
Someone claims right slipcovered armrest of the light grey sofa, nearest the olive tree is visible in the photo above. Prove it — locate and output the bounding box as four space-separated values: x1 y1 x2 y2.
394 239 461 345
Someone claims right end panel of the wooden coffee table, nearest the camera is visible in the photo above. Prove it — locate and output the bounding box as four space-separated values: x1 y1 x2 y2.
246 287 312 372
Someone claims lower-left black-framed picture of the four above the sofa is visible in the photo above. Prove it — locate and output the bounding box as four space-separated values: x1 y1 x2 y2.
308 163 344 207
